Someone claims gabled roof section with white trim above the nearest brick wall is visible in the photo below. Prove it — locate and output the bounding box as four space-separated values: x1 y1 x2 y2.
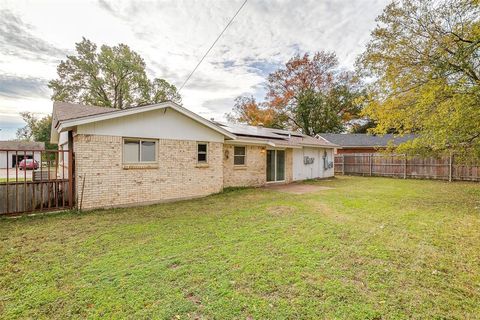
51 101 235 142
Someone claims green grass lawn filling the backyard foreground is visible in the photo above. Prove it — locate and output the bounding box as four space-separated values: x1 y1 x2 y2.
0 177 480 319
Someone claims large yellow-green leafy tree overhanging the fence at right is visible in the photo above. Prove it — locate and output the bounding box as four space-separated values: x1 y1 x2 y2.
357 0 480 156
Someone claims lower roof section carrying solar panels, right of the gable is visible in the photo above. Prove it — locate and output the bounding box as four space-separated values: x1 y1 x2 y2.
215 122 336 148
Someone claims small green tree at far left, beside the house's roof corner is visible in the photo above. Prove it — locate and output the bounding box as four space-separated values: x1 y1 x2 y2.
17 112 56 149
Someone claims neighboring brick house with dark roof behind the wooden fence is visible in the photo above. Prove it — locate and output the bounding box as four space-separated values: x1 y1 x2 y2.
319 133 415 154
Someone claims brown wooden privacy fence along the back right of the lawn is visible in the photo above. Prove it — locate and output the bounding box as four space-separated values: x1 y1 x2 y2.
335 153 480 181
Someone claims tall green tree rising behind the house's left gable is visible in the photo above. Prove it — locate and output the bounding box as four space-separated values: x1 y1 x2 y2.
49 38 181 109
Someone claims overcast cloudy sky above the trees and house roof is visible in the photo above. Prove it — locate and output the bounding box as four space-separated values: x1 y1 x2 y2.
0 0 388 140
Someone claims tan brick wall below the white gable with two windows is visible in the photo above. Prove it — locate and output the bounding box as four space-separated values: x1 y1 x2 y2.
74 134 223 209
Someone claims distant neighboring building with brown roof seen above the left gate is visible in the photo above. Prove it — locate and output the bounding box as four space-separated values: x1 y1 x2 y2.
0 141 45 169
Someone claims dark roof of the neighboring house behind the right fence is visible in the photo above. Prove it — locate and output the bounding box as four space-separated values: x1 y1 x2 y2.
319 133 415 147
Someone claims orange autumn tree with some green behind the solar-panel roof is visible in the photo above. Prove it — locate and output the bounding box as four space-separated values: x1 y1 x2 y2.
228 51 363 136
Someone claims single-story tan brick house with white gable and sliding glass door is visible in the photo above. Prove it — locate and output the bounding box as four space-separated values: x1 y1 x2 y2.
51 102 335 208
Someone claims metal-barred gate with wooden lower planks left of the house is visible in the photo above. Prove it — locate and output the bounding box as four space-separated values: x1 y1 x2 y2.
0 149 74 216
